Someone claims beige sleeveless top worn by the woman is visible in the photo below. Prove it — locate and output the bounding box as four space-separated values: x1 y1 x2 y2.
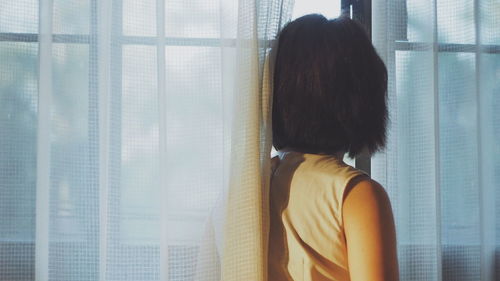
268 152 365 281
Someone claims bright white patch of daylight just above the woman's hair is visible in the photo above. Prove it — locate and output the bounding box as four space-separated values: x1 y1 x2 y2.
292 0 340 19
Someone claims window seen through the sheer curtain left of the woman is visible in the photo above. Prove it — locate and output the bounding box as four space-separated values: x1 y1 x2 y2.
0 0 229 280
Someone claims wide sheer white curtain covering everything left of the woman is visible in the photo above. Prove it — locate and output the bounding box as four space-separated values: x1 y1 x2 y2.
0 0 291 281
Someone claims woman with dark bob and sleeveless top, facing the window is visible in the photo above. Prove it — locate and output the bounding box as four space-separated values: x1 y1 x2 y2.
268 15 398 281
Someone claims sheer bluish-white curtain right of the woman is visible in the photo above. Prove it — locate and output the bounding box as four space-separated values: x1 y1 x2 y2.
372 0 500 280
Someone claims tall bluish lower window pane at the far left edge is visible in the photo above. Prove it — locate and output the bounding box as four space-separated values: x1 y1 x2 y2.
0 42 38 280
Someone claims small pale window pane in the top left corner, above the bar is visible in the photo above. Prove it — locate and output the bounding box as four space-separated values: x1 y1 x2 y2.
0 0 38 33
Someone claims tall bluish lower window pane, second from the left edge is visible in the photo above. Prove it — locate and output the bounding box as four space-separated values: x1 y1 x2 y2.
50 43 99 281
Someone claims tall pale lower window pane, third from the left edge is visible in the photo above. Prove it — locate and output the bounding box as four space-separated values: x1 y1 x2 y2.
107 45 163 280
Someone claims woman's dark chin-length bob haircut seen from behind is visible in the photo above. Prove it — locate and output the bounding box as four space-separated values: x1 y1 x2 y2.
272 14 387 157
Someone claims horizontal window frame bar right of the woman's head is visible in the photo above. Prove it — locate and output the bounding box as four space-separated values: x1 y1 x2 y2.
394 41 500 54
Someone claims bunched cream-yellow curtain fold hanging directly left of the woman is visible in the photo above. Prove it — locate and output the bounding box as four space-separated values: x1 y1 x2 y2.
200 0 293 281
